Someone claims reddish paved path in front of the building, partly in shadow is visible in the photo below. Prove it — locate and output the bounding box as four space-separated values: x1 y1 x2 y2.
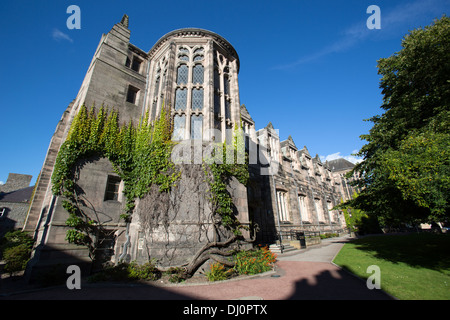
3 237 390 300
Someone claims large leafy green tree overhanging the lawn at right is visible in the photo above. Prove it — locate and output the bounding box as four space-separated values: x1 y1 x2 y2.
344 16 450 224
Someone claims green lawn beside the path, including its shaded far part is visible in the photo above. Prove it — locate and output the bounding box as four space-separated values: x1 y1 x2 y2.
333 233 450 300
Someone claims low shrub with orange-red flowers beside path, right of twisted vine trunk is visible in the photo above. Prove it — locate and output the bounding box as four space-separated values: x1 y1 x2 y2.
234 247 277 274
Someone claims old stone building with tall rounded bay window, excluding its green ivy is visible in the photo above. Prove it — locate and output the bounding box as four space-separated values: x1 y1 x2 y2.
24 15 356 278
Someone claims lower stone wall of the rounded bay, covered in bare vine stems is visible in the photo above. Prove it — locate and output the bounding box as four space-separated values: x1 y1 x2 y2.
130 164 248 266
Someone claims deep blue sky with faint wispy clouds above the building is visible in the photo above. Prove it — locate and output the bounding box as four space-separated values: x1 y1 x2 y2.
0 0 450 183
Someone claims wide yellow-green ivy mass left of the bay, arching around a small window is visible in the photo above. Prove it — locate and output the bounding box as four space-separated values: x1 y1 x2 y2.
52 105 180 252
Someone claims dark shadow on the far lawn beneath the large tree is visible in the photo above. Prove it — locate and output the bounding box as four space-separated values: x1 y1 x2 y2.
352 233 450 275
